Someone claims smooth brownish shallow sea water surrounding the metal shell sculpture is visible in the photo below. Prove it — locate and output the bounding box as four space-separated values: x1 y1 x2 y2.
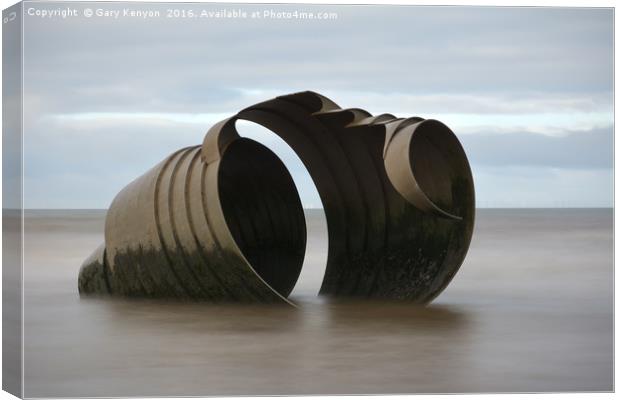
24 209 613 397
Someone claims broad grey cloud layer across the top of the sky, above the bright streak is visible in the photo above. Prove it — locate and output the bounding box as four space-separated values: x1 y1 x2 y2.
21 5 613 112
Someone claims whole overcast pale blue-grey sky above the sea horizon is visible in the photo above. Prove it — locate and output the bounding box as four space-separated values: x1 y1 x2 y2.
24 3 613 208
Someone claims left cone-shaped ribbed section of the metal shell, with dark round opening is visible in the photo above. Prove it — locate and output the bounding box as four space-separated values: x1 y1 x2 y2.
79 139 306 301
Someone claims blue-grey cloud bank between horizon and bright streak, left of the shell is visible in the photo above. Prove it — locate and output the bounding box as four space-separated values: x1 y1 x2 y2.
24 118 205 208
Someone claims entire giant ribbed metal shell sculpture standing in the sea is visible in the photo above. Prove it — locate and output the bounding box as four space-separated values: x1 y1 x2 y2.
78 92 475 303
